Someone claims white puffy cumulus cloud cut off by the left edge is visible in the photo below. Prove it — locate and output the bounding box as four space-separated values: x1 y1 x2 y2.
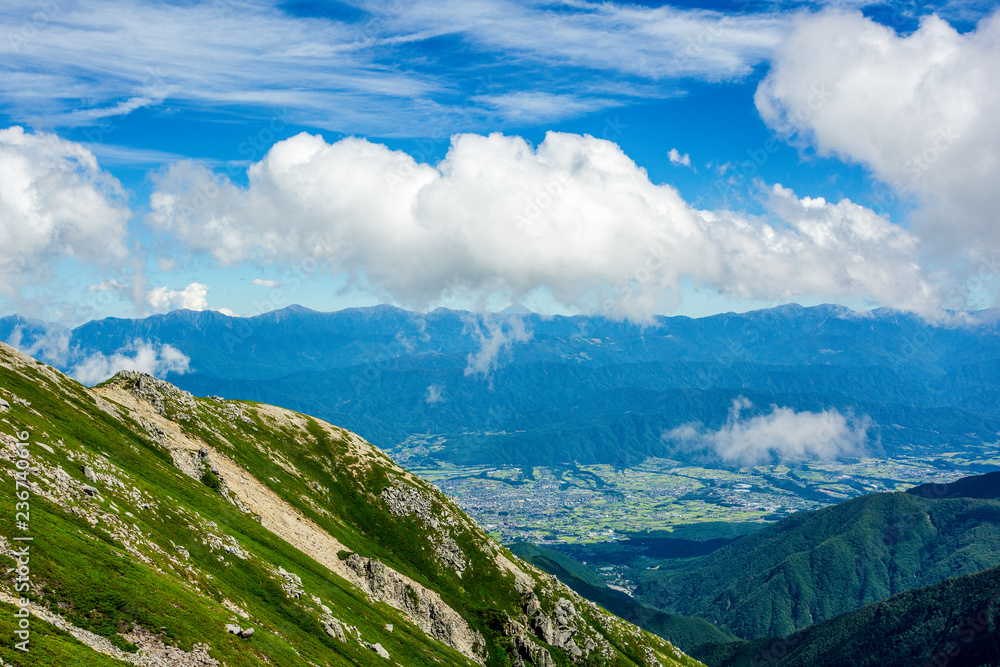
0 127 131 295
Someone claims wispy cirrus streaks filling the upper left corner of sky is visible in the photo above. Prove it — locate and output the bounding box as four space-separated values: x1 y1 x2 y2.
0 0 440 129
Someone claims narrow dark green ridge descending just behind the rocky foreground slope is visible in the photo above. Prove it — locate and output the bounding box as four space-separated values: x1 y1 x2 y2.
510 542 735 651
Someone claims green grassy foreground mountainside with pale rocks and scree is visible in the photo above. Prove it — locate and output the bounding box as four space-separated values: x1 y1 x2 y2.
0 345 697 667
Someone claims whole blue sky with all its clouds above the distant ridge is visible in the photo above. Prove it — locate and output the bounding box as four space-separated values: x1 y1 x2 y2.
0 0 1000 323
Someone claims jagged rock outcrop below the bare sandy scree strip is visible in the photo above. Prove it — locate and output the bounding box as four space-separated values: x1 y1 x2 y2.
344 554 485 662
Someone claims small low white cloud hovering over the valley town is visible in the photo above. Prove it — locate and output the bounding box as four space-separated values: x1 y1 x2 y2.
664 396 871 465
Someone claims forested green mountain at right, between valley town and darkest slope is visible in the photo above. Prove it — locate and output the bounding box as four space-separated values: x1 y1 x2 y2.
638 493 1000 639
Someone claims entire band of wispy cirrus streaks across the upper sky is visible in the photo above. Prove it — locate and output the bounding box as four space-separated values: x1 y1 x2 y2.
0 0 789 136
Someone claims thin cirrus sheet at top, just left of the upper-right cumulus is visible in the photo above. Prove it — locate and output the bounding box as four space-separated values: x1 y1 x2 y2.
375 0 788 81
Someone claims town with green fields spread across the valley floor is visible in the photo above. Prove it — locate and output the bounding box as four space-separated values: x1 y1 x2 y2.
392 451 1000 545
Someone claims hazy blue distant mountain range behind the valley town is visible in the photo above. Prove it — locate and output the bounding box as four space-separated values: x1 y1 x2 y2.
0 305 1000 465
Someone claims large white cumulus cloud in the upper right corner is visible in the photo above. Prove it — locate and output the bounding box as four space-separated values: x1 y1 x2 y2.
755 11 1000 298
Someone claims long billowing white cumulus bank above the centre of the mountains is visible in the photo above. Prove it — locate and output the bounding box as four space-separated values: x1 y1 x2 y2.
149 133 940 318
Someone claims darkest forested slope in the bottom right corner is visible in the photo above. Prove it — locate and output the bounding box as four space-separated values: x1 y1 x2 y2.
695 568 1000 667
